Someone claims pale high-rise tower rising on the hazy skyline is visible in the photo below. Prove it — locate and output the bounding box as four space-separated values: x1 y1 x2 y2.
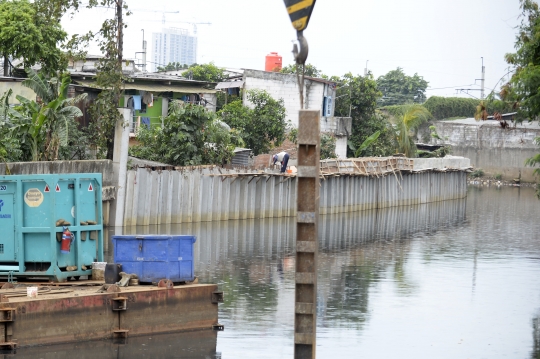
152 28 197 72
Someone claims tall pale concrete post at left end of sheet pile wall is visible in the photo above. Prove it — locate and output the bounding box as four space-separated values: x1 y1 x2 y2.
110 108 131 227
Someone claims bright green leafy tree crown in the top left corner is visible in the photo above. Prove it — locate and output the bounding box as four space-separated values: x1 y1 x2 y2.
0 0 67 76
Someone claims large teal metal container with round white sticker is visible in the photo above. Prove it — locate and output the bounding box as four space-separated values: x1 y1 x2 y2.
0 173 103 282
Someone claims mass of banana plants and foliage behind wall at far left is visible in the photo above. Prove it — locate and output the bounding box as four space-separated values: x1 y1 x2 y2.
0 69 87 162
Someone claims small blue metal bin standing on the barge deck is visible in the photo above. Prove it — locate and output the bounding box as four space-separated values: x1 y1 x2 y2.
112 235 196 282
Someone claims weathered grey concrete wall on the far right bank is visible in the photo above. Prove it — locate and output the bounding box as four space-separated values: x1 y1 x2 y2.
432 119 540 182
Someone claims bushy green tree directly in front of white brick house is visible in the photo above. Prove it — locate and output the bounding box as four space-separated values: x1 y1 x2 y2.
219 90 288 155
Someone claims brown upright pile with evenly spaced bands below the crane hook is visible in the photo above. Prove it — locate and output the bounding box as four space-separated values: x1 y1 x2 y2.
294 110 320 359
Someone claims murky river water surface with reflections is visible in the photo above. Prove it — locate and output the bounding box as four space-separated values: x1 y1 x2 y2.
17 187 540 359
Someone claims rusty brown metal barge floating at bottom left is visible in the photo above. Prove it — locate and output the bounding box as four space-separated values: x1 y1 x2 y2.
0 281 222 349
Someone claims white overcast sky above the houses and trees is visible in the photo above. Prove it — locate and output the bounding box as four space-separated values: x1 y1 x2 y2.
63 0 520 97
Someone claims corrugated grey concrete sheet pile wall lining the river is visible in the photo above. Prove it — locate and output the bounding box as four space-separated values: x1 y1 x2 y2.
124 167 467 226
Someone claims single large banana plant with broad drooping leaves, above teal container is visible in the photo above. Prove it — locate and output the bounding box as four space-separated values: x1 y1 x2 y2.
10 69 86 161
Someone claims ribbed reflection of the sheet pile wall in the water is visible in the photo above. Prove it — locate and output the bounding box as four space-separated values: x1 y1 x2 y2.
116 199 466 273
